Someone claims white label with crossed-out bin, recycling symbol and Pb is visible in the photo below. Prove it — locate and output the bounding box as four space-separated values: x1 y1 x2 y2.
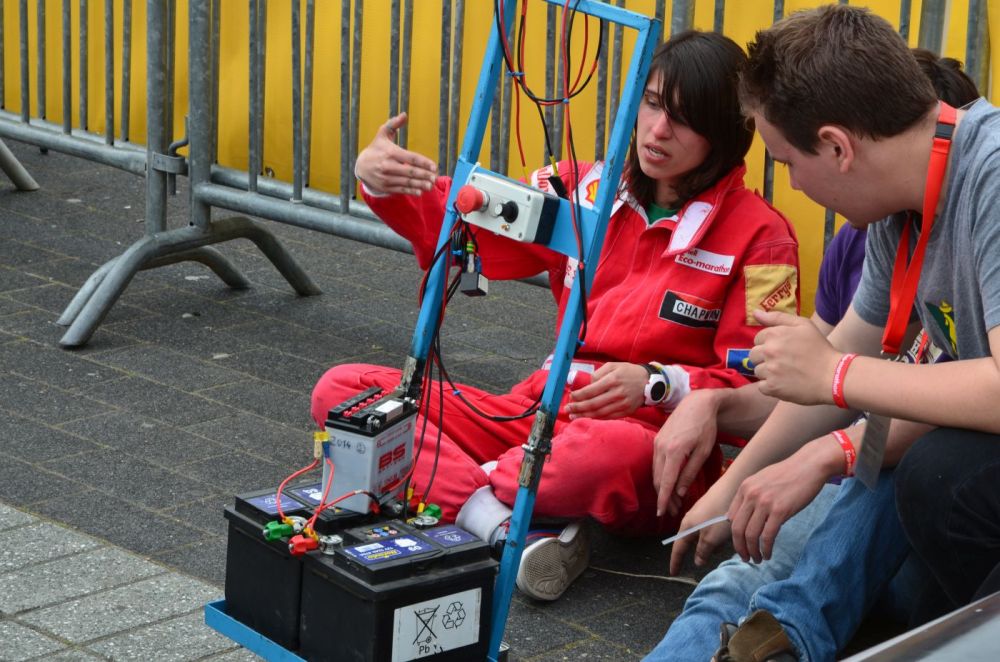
392 588 483 662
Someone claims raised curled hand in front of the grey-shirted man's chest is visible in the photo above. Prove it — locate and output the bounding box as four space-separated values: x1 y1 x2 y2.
750 310 840 405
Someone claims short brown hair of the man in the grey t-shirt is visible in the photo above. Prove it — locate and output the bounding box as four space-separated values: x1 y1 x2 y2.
740 5 937 154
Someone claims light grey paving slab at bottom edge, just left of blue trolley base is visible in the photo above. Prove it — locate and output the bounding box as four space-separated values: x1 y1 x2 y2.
89 613 233 662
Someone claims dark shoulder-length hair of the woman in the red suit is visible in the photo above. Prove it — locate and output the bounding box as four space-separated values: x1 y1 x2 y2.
625 30 753 207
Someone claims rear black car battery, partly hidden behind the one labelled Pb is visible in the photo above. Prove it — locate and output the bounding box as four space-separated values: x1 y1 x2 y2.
224 483 373 650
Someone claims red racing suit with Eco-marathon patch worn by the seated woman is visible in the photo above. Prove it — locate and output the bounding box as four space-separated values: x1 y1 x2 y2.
312 163 798 534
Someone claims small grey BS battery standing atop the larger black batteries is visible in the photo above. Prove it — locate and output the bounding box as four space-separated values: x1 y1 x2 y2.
323 387 417 513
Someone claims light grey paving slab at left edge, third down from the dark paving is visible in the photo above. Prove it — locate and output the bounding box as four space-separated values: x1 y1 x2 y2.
0 547 166 615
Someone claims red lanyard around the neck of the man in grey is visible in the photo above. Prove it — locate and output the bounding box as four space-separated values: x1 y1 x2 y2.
882 101 955 355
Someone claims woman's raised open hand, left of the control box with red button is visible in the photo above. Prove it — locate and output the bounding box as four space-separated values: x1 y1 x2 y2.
354 113 437 195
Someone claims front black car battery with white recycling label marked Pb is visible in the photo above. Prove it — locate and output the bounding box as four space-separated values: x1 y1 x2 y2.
299 521 497 662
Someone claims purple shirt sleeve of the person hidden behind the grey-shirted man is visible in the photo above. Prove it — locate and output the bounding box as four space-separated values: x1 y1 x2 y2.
816 224 867 326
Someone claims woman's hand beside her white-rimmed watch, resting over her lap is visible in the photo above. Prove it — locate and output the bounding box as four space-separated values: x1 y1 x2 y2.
566 363 649 418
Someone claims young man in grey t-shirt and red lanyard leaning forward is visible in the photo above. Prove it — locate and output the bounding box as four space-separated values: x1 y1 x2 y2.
672 5 1000 662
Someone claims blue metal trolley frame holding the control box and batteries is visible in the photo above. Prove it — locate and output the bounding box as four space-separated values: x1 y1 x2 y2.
205 0 661 662
